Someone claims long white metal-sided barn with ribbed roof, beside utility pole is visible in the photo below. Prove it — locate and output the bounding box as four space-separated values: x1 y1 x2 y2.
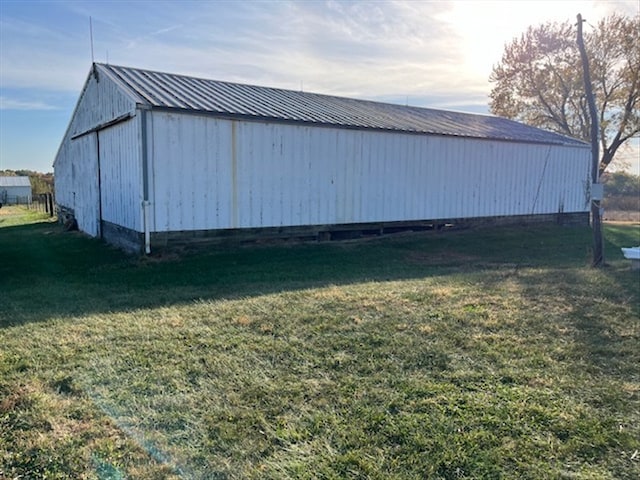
54 64 591 252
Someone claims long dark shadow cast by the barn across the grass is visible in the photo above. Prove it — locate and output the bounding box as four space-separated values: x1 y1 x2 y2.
0 223 636 334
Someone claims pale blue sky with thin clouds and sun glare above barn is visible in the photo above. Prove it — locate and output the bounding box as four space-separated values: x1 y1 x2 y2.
0 0 640 174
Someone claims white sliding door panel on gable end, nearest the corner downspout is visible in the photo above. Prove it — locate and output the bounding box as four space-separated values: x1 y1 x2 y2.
99 117 143 232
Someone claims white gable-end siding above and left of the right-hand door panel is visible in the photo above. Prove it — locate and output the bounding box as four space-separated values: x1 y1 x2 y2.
54 70 139 236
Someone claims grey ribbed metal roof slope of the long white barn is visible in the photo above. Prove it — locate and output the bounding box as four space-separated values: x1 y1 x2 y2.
95 64 586 145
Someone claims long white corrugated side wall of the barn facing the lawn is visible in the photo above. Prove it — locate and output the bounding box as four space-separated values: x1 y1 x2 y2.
151 112 589 231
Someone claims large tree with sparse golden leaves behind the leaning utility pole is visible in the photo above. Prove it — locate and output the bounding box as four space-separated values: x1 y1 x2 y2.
489 14 640 174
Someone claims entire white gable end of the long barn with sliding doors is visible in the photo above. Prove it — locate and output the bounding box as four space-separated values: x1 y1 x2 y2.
54 67 142 236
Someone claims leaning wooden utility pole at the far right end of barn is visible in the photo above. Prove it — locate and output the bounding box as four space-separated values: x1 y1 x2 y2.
578 14 604 267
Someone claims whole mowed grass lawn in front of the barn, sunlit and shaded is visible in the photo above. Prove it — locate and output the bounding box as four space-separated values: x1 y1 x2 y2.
0 207 640 479
